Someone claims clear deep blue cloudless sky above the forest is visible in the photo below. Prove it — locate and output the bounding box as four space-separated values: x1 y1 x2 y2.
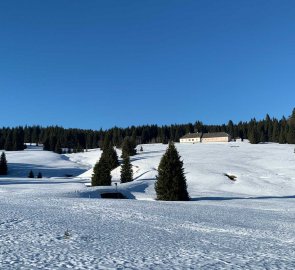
0 0 295 129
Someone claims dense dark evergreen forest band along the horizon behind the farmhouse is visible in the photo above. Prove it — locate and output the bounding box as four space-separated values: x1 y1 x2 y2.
0 109 295 153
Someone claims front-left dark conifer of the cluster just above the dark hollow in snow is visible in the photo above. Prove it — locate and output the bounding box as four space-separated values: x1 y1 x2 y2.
91 156 112 186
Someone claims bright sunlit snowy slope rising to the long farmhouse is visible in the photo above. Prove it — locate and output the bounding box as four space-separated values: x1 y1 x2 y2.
68 142 295 199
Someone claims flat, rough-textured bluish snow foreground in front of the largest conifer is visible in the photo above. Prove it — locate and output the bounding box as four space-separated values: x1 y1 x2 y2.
0 177 295 269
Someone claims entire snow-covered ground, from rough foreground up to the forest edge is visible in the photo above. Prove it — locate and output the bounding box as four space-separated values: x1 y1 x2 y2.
0 142 295 269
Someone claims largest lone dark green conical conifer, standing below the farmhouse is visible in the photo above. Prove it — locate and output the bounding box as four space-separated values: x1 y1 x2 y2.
155 142 189 201
